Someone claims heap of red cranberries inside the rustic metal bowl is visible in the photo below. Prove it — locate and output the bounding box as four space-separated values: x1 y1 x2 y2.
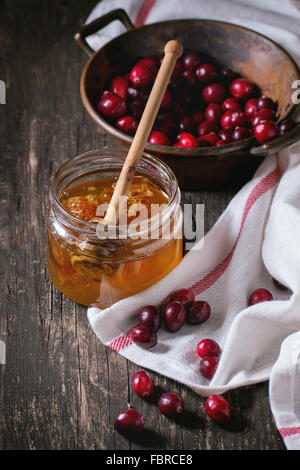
97 51 294 148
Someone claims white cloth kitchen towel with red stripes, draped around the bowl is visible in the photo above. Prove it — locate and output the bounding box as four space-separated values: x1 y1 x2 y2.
84 0 300 449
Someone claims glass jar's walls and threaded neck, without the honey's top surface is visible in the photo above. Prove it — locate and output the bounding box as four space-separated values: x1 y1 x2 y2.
47 148 182 308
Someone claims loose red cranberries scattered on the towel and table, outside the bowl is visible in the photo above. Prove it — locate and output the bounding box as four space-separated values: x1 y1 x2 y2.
114 286 274 435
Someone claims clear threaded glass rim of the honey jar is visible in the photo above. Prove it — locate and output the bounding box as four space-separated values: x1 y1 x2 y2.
50 147 180 236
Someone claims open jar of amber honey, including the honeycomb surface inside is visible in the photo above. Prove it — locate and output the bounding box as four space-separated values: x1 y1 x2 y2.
47 148 182 308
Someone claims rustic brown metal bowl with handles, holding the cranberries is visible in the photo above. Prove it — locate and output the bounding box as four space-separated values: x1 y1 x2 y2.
75 9 300 190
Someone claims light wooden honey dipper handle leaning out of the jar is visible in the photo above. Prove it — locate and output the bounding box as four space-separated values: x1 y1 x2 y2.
102 41 183 225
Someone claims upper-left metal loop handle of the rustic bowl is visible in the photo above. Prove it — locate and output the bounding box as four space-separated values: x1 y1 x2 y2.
74 8 134 57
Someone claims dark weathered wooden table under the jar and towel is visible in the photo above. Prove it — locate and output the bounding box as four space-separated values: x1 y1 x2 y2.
0 0 284 450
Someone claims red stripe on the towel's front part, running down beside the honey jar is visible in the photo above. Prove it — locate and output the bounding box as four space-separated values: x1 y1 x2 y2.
108 168 278 350
